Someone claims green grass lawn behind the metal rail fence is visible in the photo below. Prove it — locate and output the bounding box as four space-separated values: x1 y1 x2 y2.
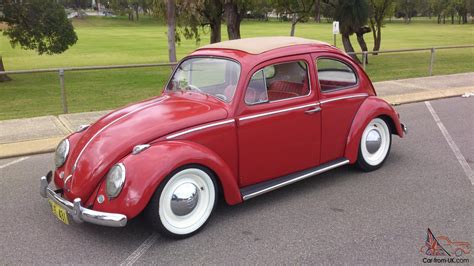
0 17 474 119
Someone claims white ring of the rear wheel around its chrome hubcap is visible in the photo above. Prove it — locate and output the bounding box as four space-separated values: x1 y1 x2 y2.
360 118 391 166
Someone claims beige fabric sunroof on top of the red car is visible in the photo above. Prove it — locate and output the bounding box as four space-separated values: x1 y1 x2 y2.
197 36 330 55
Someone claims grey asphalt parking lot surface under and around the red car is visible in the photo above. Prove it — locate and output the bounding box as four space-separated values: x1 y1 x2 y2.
0 97 474 265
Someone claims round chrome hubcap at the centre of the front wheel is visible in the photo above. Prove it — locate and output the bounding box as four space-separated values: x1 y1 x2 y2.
171 183 199 216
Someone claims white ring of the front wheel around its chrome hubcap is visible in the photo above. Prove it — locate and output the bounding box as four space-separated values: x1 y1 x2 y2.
158 168 216 235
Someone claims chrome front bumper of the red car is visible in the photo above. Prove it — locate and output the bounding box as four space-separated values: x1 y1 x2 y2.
40 172 127 227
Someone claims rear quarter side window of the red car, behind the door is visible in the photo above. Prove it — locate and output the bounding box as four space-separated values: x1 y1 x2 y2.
317 58 357 92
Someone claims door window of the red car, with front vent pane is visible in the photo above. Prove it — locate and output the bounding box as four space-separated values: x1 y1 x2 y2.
245 61 310 104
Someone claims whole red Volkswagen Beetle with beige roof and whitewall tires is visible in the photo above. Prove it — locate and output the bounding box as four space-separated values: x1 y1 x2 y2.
40 37 406 238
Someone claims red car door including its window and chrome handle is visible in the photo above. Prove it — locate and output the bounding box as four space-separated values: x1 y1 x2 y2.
237 55 321 187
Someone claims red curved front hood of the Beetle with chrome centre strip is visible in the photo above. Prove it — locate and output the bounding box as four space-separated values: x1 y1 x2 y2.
64 94 228 201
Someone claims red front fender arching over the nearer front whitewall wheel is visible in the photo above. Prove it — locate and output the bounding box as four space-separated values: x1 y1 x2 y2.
94 140 242 219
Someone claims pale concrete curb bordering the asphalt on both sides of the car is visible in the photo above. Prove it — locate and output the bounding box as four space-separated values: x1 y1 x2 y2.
0 86 474 159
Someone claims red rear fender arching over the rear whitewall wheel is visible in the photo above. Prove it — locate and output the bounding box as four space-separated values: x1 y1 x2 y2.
345 96 403 163
